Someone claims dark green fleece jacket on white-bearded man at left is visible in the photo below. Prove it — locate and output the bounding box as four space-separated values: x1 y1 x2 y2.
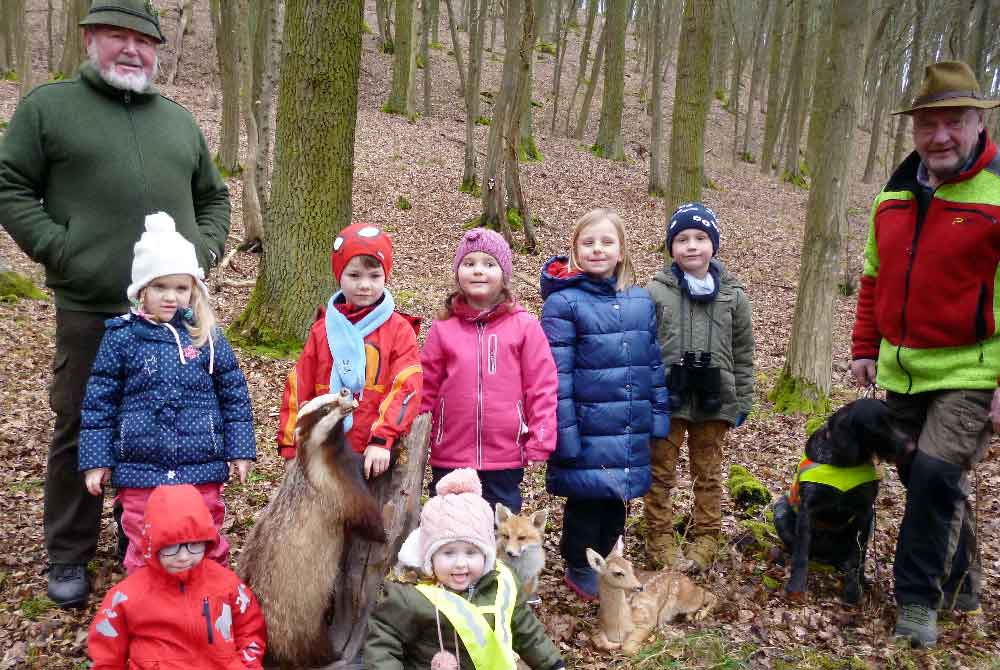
0 63 229 312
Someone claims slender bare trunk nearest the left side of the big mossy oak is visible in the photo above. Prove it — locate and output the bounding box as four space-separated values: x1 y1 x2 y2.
233 0 264 245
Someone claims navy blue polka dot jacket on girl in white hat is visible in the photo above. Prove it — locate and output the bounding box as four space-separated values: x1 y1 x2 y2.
79 314 257 488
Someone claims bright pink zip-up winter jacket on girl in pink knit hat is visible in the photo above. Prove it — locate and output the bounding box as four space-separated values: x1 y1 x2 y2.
420 303 558 470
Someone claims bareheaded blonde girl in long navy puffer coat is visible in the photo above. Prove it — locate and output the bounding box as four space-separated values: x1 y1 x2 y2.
541 209 670 600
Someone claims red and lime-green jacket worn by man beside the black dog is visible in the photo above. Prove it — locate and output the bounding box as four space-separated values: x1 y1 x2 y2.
851 131 1000 393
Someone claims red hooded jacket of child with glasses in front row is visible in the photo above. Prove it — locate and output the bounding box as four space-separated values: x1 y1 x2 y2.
87 484 267 670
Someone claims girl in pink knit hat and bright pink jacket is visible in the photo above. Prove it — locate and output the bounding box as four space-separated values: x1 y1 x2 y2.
420 228 559 514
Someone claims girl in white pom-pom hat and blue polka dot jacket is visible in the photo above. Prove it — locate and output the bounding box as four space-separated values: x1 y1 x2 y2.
79 212 257 574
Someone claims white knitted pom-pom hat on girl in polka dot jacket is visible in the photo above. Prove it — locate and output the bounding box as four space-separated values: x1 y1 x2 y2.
126 212 208 300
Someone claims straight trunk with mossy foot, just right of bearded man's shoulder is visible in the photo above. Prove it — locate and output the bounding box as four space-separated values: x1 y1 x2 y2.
213 0 240 176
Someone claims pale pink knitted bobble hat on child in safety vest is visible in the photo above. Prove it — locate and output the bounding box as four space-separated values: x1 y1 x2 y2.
399 468 497 577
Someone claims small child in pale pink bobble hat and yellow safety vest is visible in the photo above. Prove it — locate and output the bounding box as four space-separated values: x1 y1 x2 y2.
365 468 565 670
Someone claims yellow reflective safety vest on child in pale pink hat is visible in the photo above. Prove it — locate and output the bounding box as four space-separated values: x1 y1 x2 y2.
416 562 517 670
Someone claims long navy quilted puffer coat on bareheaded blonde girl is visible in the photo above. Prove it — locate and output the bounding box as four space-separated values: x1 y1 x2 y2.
541 256 670 500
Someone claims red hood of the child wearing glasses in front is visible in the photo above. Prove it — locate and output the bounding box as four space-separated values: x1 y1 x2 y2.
143 484 219 581
